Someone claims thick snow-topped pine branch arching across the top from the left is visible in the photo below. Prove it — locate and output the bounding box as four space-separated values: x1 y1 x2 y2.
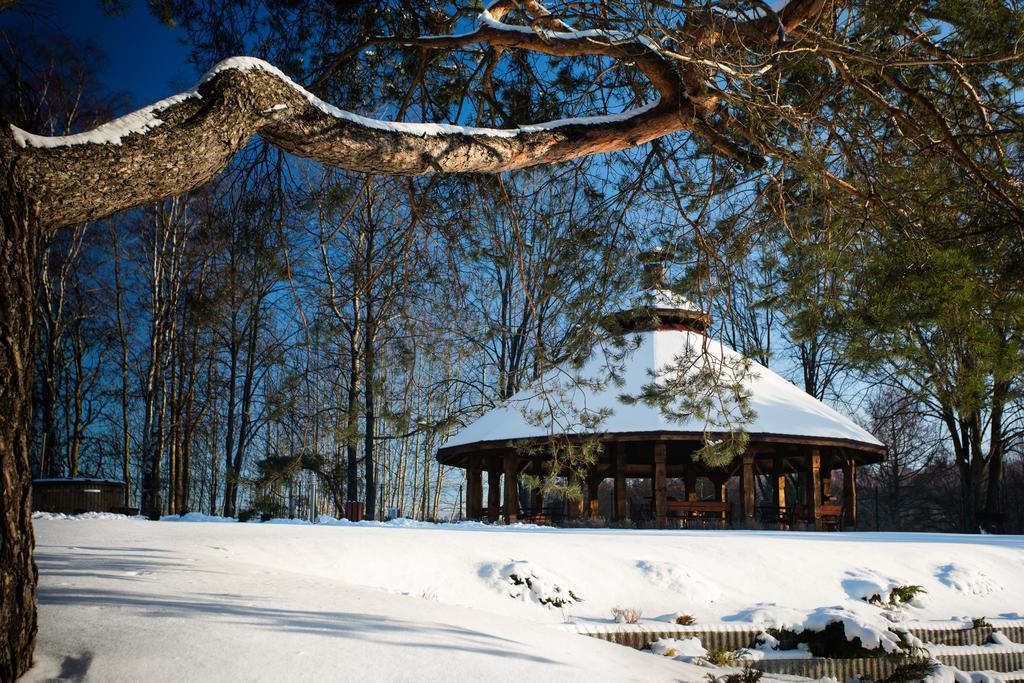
0 0 824 232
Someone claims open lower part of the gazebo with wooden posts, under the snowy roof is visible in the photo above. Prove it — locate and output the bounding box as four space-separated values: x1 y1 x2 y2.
438 433 885 529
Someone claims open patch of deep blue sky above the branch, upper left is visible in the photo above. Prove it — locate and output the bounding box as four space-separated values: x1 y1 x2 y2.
0 0 198 109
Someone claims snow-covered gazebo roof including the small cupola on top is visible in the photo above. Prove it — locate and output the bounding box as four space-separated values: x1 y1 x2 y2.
437 251 886 462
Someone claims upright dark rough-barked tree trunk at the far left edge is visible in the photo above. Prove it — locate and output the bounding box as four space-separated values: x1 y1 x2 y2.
0 158 41 681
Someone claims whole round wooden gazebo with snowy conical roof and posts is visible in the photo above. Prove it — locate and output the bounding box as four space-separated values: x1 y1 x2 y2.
437 264 886 528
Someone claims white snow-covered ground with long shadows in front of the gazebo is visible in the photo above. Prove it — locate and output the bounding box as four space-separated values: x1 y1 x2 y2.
25 515 1024 681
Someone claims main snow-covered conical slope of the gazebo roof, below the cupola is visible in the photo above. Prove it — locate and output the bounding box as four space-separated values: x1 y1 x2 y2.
438 329 885 456
